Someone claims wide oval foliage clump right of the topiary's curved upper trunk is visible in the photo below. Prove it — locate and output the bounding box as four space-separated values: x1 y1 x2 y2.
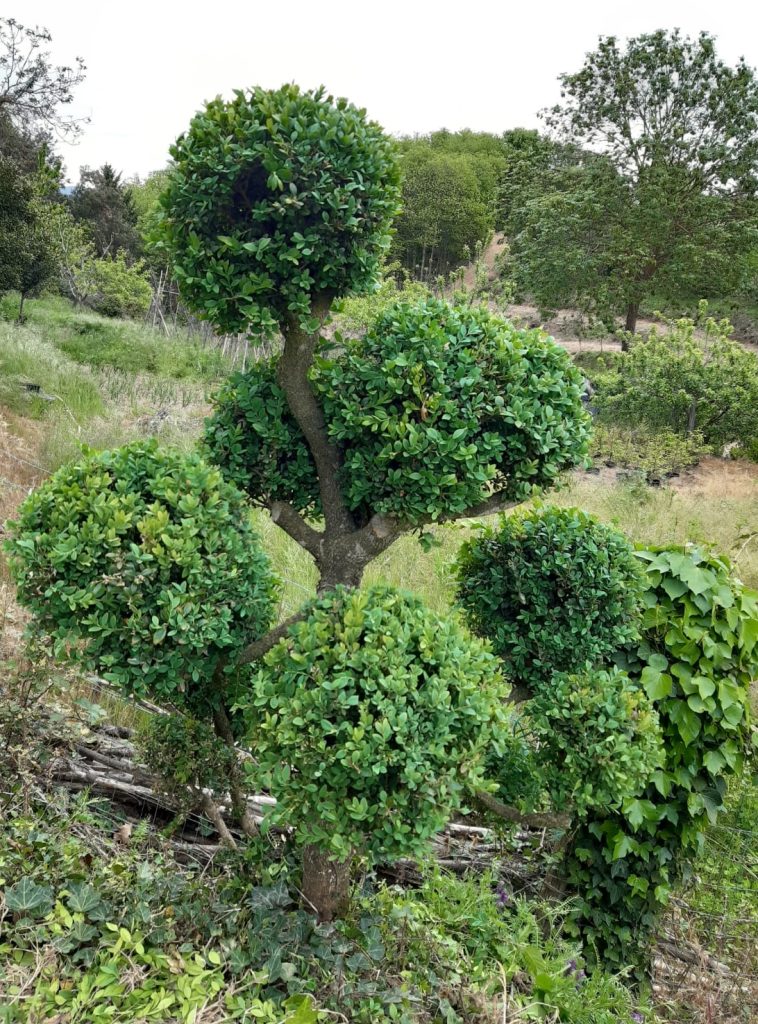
317 299 589 523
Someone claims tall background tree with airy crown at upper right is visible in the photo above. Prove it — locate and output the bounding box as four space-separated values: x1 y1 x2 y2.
506 30 758 332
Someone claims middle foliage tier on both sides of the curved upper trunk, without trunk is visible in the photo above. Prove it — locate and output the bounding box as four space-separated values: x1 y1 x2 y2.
206 299 588 525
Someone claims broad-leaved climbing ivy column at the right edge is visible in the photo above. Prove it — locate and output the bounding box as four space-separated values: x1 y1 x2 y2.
565 547 758 966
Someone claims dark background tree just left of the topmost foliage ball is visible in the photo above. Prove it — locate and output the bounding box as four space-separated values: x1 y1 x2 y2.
69 164 142 259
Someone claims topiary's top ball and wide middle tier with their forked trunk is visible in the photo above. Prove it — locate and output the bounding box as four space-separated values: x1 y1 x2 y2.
162 85 588 634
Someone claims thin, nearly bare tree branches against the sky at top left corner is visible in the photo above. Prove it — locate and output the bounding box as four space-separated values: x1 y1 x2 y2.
0 17 86 138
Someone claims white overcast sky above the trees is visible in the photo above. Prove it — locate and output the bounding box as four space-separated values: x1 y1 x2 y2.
14 0 758 179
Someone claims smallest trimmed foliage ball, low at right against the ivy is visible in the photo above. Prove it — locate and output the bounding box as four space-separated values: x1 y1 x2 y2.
527 669 664 816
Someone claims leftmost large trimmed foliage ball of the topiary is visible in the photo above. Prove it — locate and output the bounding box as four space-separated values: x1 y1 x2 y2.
7 441 275 713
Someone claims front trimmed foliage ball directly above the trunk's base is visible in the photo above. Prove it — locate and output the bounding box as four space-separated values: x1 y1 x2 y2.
246 587 506 861
